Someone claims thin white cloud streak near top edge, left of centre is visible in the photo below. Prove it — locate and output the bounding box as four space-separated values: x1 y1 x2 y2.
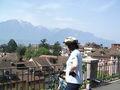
39 3 62 9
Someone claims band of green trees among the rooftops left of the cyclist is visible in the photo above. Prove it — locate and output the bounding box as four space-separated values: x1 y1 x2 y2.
8 39 61 59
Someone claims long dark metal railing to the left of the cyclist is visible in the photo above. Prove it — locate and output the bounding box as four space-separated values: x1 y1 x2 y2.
0 65 64 90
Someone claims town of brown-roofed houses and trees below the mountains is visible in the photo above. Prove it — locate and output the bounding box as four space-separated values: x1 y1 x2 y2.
0 39 120 90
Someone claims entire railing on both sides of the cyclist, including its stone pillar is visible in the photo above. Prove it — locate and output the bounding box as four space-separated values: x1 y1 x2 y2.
0 57 120 90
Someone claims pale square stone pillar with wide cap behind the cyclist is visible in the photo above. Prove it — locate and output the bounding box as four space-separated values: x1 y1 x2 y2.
83 56 99 90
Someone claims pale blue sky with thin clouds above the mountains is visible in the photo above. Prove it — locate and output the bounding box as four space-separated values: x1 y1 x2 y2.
0 0 120 43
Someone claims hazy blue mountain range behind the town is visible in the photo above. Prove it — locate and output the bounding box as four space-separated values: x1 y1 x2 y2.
0 20 115 46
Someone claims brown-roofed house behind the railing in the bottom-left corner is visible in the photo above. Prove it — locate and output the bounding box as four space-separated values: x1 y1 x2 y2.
0 61 45 90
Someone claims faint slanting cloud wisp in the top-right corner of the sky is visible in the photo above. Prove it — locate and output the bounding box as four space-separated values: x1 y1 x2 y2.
92 0 116 12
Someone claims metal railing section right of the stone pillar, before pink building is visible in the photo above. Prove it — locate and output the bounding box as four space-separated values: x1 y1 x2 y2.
97 61 120 82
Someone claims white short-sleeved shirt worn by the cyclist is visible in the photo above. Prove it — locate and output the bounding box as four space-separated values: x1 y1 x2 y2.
66 49 83 84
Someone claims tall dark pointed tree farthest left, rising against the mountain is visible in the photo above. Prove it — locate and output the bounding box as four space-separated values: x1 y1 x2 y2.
7 39 17 53
